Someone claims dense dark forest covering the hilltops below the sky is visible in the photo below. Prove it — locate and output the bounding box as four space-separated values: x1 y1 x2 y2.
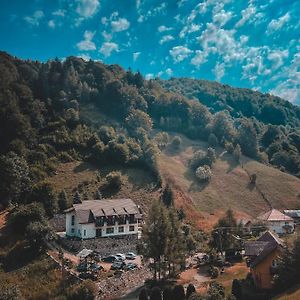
0 52 300 211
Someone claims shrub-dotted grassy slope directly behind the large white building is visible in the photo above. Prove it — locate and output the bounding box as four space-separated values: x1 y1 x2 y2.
48 161 159 210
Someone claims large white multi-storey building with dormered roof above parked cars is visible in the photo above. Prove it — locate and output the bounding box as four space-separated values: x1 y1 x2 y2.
65 199 142 239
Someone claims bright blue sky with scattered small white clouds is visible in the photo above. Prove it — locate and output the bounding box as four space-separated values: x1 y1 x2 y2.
0 0 300 104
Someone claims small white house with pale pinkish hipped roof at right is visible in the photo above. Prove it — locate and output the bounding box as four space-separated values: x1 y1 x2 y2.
257 208 295 234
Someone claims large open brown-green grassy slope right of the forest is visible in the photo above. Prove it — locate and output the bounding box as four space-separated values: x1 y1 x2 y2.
159 132 300 226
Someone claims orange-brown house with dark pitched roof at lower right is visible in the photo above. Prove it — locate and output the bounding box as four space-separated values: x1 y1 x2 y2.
245 231 284 289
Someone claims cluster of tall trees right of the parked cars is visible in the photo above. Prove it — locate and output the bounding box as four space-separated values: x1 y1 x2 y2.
142 201 186 279
